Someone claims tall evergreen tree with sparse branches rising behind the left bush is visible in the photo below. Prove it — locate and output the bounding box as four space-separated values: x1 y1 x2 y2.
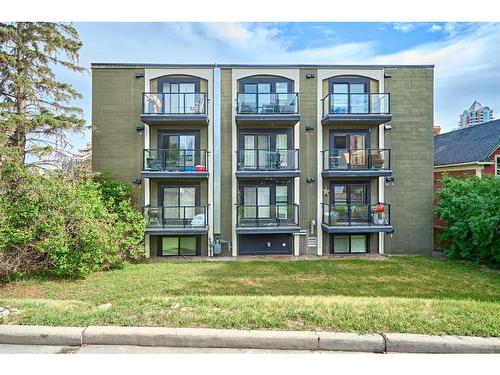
0 22 86 166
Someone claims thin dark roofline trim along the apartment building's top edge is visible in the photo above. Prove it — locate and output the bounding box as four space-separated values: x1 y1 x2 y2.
90 63 434 69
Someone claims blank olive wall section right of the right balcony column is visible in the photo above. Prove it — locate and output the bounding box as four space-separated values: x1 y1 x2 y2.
385 68 434 255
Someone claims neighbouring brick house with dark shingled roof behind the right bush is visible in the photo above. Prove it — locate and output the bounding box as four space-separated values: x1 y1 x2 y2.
434 120 500 249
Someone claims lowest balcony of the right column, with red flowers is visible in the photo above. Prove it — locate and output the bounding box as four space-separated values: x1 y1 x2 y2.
321 203 394 233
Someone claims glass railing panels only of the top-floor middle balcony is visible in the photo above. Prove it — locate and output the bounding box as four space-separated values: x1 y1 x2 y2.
236 93 299 115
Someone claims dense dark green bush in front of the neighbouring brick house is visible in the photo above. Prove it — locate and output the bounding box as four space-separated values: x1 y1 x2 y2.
435 176 500 266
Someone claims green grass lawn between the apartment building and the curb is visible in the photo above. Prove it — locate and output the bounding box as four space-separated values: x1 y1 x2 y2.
0 257 500 336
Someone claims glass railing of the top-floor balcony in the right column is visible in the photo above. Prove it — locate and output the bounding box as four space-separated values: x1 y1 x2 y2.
323 93 391 117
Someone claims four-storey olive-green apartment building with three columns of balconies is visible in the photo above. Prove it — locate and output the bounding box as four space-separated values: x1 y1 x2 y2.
92 64 434 257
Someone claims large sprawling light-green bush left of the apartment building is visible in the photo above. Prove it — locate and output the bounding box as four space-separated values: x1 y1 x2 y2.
0 165 144 280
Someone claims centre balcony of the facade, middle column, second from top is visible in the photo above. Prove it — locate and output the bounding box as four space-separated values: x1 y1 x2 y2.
236 149 300 178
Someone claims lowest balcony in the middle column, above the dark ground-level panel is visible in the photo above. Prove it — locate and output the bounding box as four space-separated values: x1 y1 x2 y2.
236 204 300 234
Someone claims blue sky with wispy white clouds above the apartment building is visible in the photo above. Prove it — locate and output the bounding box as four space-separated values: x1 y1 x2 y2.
61 22 500 153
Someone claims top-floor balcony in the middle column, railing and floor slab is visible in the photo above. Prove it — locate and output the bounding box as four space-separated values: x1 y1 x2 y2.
236 93 300 125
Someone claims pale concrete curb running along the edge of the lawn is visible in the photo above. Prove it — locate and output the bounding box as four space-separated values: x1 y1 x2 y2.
0 325 500 353
